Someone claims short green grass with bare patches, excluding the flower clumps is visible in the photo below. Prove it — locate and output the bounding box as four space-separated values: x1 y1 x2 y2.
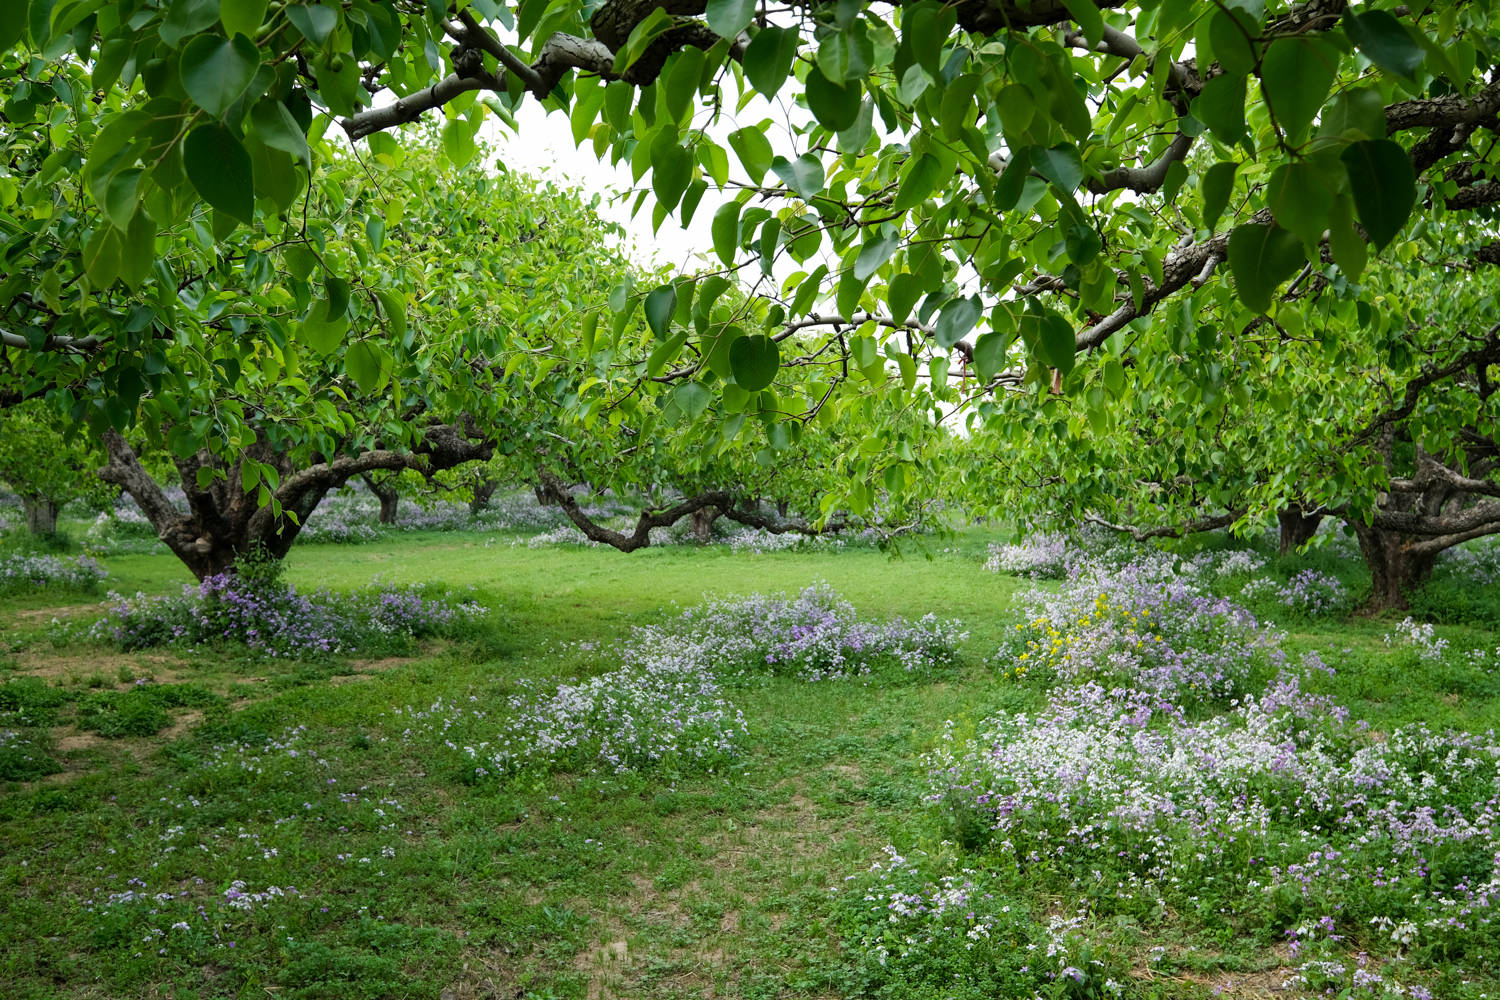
0 534 1500 999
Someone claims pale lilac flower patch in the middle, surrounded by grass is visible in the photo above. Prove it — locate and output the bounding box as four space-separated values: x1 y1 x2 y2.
393 585 965 778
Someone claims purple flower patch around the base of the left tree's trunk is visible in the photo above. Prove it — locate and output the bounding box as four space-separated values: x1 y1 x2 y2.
87 573 486 658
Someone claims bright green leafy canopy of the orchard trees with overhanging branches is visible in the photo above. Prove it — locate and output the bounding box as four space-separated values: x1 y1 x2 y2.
0 0 1500 603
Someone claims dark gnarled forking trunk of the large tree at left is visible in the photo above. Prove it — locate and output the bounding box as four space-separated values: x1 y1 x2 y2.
99 424 494 580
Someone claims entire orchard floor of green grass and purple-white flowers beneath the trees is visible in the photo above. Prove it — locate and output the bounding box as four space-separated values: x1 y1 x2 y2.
0 509 1500 1000
